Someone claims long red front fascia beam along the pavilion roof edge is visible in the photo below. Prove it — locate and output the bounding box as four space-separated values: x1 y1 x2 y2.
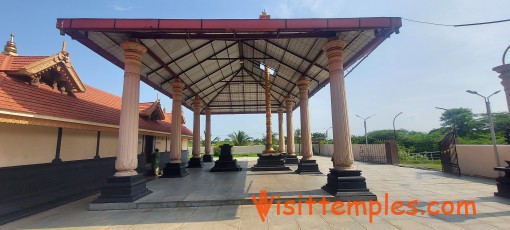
57 17 402 32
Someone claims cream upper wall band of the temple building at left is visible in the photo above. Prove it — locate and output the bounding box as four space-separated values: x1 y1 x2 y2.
0 123 189 167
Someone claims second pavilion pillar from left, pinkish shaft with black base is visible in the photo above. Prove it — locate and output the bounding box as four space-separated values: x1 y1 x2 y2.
162 79 188 177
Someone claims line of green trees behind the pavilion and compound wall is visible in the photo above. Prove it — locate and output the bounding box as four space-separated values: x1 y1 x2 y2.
204 108 510 152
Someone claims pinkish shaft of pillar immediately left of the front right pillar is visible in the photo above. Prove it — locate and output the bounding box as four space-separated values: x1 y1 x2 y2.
298 77 313 160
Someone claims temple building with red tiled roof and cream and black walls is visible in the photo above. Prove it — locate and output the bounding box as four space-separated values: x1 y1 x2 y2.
0 35 193 221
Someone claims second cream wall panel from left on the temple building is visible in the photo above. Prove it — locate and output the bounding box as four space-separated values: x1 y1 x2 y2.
60 129 97 161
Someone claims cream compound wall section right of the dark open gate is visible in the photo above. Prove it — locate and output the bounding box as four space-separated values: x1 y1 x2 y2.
457 145 510 178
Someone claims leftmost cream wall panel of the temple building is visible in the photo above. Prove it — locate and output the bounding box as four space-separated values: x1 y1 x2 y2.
0 123 58 167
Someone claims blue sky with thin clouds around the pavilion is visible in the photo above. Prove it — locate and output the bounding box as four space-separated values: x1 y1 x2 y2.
0 0 510 139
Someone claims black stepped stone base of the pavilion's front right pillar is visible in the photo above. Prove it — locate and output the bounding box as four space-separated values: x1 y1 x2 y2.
322 169 377 201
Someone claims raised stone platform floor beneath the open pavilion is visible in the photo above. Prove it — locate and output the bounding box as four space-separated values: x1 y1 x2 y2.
89 160 332 210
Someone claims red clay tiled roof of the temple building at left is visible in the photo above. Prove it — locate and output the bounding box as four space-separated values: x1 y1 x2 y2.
0 55 192 135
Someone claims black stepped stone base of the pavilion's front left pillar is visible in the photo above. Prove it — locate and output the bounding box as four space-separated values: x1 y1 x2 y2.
92 174 152 203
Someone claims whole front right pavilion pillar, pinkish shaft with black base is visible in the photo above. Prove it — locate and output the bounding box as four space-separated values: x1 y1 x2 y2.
322 38 377 200
